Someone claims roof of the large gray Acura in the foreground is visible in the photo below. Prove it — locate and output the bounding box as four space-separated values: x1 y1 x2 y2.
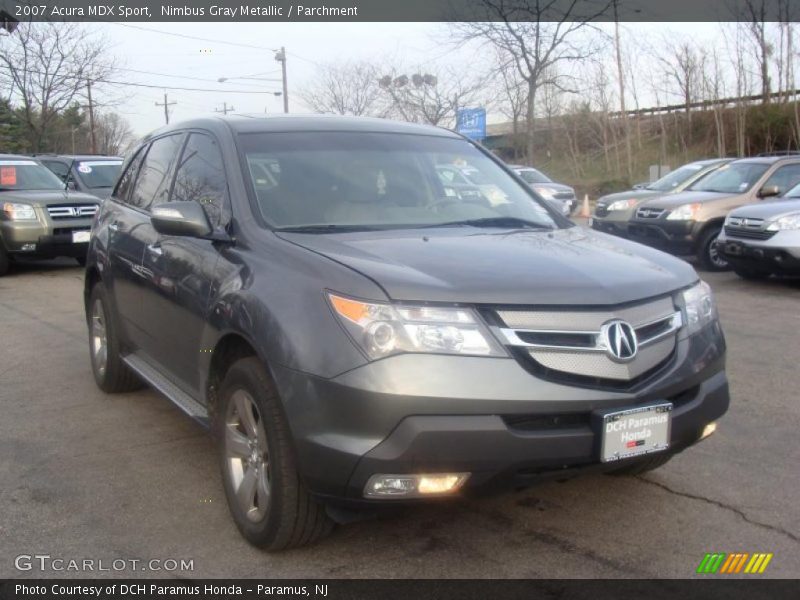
145 114 463 139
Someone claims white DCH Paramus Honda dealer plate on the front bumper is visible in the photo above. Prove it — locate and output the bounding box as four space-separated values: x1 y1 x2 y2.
600 402 672 462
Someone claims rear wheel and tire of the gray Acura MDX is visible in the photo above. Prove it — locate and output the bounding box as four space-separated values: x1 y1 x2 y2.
87 283 143 394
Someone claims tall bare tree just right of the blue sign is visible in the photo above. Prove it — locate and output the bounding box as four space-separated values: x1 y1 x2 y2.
451 0 613 161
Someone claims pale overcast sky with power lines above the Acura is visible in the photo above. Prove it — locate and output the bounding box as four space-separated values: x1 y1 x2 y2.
93 23 717 135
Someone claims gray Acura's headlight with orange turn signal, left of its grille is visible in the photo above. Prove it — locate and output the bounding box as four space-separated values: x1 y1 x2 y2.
328 294 506 359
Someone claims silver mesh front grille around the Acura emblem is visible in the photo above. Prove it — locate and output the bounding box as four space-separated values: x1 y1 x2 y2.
494 298 683 386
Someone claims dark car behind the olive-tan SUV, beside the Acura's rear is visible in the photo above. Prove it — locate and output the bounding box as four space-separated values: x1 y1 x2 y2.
33 154 122 200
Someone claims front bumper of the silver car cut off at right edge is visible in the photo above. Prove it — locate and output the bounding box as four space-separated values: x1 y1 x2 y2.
717 231 800 275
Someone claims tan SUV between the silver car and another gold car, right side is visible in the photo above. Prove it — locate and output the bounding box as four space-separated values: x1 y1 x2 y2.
628 156 800 271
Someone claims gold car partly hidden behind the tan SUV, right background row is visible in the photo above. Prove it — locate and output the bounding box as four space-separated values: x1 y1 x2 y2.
589 158 733 237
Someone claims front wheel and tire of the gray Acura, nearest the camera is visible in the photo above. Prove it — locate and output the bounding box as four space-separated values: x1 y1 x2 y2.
214 357 333 551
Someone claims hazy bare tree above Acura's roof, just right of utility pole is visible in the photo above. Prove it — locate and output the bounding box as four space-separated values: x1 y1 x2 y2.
300 62 382 116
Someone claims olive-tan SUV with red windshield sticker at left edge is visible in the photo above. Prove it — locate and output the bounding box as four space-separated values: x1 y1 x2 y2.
0 154 99 276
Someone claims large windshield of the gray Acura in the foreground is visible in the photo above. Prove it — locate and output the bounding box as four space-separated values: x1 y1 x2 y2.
239 132 557 232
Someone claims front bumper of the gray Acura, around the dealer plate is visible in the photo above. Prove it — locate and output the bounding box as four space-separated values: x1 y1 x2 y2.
273 324 729 506
